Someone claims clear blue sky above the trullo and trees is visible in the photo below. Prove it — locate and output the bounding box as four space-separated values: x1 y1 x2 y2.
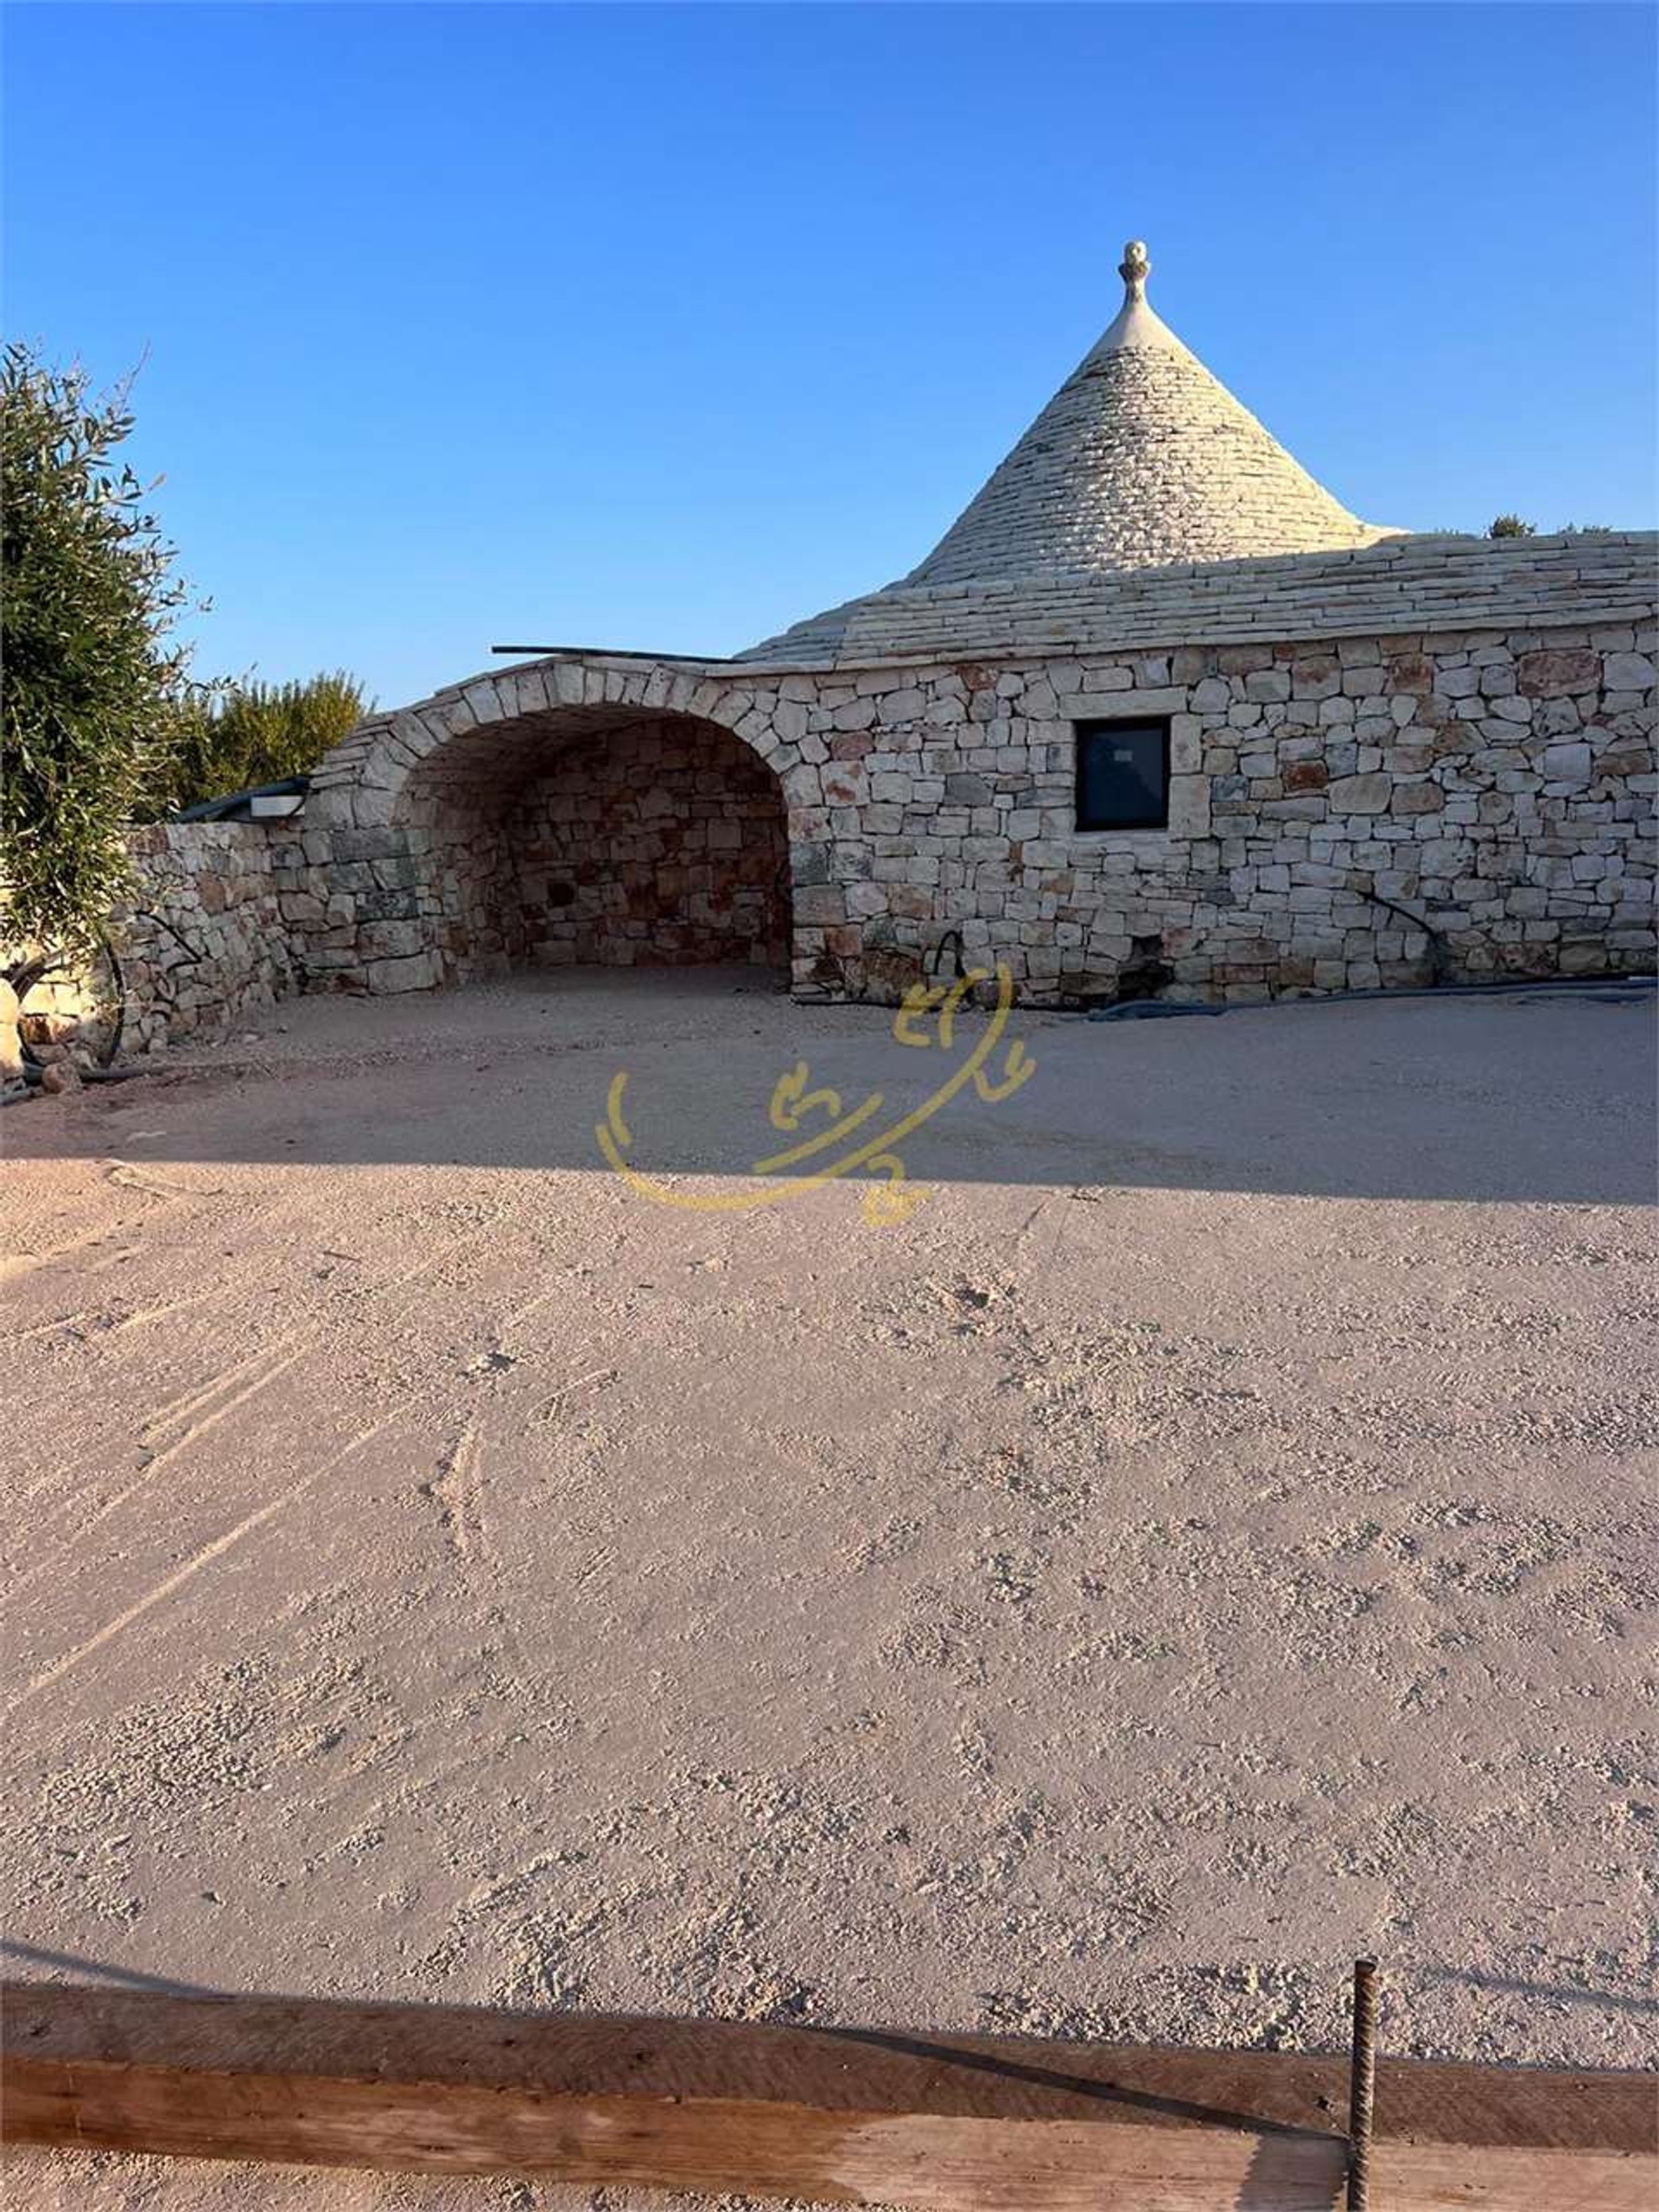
4 4 1655 703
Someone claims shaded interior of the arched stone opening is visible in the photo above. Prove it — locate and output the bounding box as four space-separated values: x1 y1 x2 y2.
387 706 790 982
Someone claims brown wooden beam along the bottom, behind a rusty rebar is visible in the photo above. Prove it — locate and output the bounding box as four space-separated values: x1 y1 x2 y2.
0 1982 1659 2212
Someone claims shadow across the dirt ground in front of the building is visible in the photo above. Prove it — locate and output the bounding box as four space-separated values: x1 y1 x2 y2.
3 969 1655 1205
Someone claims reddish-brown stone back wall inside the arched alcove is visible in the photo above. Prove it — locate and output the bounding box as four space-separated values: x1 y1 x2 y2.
513 721 790 967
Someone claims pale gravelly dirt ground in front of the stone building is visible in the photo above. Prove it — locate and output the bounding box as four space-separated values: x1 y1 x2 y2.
0 973 1659 2212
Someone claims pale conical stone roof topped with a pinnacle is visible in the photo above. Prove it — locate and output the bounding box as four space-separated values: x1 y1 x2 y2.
900 238 1394 588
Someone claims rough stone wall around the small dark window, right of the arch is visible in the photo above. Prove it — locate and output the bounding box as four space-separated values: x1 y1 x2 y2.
797 628 1655 1004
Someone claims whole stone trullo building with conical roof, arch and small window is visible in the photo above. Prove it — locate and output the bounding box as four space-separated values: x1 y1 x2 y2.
111 245 1655 1039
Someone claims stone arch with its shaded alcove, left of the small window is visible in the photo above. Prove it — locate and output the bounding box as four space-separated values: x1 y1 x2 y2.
305 659 817 991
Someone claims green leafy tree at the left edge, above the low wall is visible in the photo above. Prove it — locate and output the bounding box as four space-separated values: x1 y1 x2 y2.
0 345 190 951
